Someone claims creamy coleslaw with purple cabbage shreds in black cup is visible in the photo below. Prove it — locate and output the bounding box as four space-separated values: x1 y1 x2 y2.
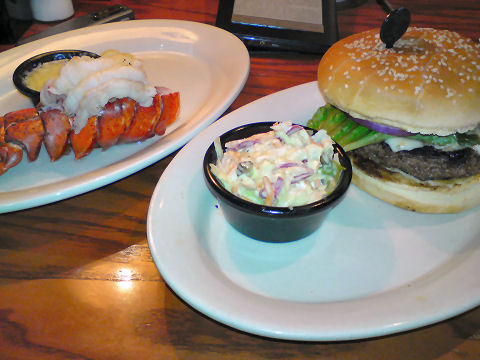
210 122 342 207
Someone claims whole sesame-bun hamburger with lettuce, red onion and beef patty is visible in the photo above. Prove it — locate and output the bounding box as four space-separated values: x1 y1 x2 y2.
308 28 480 213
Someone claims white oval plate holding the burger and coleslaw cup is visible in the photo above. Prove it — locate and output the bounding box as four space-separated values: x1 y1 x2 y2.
147 83 480 341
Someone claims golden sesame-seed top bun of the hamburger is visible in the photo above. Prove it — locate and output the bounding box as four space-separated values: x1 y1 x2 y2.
318 28 480 135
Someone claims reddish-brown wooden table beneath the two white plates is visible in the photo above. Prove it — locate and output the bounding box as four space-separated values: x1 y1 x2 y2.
0 0 480 360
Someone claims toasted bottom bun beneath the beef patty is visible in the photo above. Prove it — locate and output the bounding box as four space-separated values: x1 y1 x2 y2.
349 154 480 213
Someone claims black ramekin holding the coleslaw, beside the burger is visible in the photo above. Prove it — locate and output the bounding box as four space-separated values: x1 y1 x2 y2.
203 122 352 242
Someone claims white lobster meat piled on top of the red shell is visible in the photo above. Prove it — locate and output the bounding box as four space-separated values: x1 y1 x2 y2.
40 50 156 133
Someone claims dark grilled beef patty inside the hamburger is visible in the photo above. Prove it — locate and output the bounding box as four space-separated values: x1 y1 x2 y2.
351 143 480 181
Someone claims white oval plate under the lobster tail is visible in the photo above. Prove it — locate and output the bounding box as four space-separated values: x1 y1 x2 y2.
0 20 250 212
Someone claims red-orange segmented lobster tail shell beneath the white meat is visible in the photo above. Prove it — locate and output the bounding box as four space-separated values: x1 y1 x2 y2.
0 88 180 175
